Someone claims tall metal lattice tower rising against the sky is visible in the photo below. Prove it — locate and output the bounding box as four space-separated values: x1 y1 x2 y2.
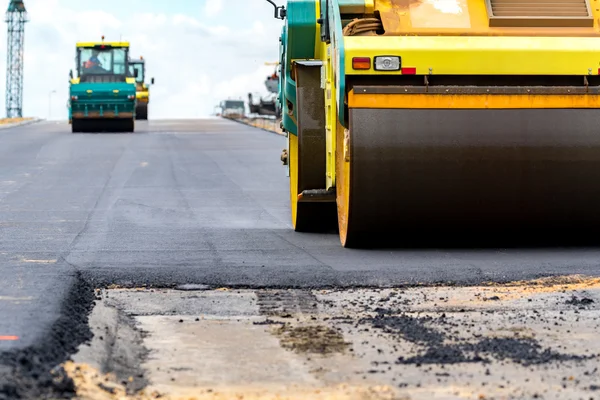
5 0 28 118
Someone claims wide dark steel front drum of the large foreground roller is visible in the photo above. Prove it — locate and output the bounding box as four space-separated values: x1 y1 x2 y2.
337 108 600 246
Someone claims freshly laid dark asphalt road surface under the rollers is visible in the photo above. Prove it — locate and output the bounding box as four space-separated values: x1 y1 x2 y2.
0 119 600 399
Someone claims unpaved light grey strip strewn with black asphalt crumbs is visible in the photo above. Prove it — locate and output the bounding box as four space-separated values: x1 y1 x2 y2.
65 279 600 400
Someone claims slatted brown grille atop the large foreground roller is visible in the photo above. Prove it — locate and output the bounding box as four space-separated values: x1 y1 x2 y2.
486 0 594 27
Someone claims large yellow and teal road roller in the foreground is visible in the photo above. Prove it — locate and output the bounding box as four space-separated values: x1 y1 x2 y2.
267 0 600 247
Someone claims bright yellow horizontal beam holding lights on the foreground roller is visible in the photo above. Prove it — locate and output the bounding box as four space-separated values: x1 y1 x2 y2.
344 36 600 75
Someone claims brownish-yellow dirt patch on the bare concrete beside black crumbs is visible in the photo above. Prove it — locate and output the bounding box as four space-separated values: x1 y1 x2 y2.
274 325 350 354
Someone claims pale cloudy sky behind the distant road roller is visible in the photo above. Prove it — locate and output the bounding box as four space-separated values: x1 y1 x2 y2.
0 0 282 120
